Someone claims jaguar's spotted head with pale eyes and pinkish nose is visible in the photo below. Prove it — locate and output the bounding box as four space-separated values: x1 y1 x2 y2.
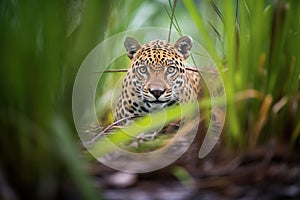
125 37 190 107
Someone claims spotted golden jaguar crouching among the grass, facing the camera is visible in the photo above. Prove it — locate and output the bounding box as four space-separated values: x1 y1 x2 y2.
114 36 201 125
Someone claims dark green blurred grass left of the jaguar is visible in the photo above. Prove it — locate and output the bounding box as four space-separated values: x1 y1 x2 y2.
0 0 113 200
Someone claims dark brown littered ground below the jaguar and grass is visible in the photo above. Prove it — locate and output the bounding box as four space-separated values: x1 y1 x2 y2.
90 138 300 200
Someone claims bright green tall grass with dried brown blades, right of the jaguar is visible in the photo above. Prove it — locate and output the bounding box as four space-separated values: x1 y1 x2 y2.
184 0 300 148
